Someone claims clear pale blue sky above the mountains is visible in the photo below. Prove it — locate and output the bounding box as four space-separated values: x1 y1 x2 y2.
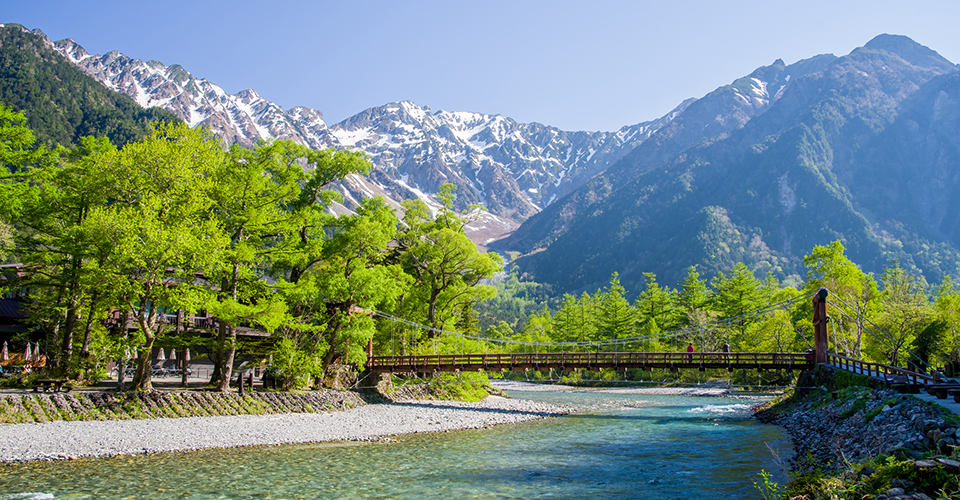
0 0 960 130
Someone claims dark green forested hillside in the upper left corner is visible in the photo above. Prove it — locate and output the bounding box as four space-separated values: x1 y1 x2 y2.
0 24 180 145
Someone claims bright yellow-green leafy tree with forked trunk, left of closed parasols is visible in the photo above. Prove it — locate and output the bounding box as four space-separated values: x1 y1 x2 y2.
80 125 227 390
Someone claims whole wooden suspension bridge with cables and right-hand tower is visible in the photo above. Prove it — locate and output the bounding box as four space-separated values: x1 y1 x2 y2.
366 288 960 402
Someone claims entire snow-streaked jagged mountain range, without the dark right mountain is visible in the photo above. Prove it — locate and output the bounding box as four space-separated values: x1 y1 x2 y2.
47 30 693 243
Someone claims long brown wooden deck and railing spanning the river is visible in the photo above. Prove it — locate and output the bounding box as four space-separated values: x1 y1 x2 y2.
367 352 813 373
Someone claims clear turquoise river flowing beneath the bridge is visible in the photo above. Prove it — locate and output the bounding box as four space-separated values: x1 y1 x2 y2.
0 392 792 500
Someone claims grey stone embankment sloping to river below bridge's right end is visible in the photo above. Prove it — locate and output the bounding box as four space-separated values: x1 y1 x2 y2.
756 368 960 500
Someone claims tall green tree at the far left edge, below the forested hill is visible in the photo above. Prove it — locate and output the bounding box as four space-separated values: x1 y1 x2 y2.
0 118 122 376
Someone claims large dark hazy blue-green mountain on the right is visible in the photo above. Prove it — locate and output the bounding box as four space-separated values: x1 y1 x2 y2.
502 35 960 291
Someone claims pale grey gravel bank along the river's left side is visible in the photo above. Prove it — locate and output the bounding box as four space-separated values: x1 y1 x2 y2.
0 396 573 462
